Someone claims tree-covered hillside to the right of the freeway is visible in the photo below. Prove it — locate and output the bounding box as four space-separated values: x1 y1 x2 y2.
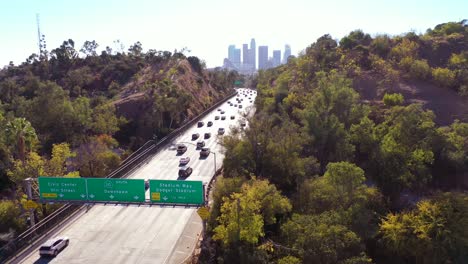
204 21 468 263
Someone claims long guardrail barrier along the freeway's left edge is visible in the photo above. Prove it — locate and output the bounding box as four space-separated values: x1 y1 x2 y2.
0 90 236 262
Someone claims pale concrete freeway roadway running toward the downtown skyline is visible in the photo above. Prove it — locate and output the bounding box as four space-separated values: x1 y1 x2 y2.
13 89 256 264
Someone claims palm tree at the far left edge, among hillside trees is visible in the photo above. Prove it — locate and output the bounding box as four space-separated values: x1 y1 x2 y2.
6 117 38 162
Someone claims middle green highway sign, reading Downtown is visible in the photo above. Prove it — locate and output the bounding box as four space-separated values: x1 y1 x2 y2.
86 178 145 202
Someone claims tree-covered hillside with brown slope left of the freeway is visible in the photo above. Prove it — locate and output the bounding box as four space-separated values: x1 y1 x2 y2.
0 39 239 245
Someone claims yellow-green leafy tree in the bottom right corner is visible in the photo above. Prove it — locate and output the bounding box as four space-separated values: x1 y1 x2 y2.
380 193 468 263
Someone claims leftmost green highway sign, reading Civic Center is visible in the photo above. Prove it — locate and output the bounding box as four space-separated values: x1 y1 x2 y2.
39 177 87 201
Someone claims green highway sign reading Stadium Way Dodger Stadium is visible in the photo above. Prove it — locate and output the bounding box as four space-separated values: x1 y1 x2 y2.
149 180 204 204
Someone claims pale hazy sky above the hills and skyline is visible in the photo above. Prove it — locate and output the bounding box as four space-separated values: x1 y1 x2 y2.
0 0 468 67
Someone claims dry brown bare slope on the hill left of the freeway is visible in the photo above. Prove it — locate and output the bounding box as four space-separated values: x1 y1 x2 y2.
114 59 231 143
